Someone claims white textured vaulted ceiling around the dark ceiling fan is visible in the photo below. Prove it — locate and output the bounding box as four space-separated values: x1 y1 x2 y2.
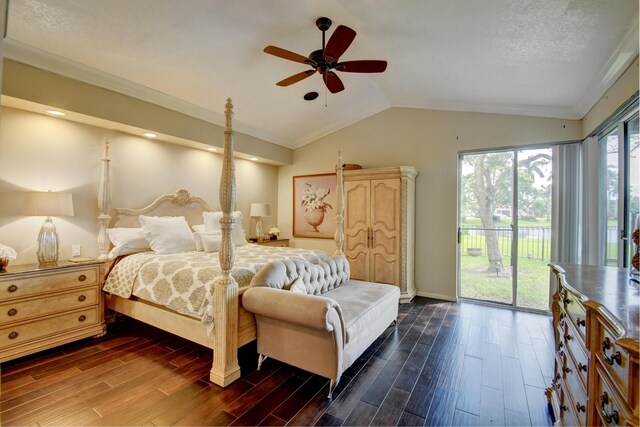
8 0 638 147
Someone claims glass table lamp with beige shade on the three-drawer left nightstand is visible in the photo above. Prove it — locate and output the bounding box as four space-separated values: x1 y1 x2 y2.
23 191 73 264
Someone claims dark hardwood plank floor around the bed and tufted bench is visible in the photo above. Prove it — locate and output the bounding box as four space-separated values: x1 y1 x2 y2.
0 298 553 426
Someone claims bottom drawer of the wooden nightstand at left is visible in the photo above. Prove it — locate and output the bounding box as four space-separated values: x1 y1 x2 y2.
0 307 102 348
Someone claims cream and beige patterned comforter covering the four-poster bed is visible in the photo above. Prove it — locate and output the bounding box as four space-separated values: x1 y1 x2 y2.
103 244 328 326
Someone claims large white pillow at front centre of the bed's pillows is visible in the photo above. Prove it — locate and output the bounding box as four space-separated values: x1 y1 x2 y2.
138 215 196 254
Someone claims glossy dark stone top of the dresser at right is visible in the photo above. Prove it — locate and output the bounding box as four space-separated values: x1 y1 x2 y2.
552 263 640 341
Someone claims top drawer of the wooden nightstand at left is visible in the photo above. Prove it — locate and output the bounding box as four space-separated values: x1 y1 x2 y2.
0 267 99 301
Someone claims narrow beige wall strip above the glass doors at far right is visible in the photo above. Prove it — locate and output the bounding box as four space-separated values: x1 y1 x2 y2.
582 58 640 138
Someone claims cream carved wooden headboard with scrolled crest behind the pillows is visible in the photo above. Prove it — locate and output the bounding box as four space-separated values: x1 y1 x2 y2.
114 189 214 227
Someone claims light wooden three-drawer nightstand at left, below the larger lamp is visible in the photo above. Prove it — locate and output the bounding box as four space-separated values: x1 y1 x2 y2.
0 261 106 362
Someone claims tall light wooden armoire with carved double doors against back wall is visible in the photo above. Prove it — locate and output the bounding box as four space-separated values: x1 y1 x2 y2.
344 166 418 303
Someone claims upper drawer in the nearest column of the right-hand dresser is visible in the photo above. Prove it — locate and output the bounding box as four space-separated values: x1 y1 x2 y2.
593 316 630 399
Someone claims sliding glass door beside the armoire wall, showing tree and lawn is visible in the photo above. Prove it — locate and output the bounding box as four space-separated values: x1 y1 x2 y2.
458 148 551 311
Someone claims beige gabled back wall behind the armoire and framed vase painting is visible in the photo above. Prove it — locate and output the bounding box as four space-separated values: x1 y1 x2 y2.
278 108 581 298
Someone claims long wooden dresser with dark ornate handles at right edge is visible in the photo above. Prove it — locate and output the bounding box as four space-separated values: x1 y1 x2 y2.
546 264 640 426
